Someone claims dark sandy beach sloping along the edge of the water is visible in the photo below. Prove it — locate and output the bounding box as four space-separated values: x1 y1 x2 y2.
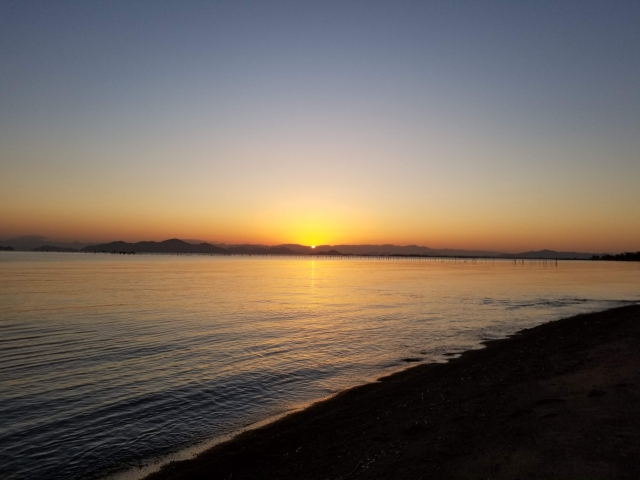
148 305 640 480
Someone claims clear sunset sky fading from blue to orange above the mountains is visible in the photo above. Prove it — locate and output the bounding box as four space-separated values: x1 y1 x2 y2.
0 0 640 252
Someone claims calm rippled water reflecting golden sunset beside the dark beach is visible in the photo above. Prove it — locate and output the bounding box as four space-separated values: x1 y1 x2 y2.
0 252 640 479
